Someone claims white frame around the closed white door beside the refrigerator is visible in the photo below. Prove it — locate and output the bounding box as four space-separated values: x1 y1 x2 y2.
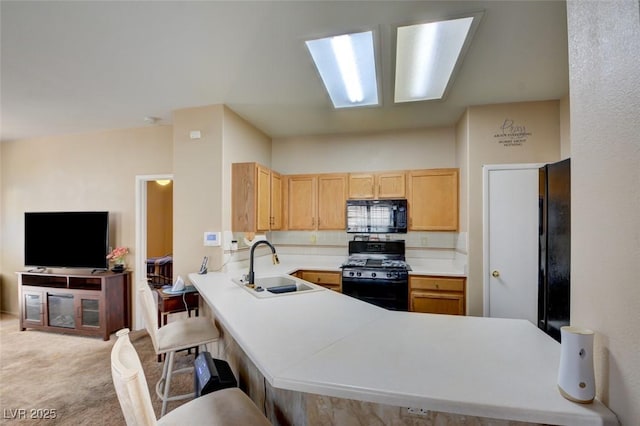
482 163 546 317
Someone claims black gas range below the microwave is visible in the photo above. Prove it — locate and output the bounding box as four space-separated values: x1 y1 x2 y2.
342 240 411 311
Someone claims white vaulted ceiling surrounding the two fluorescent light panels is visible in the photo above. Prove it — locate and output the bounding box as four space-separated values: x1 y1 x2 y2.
0 0 569 140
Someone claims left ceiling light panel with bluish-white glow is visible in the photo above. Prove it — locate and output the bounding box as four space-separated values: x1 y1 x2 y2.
306 31 378 108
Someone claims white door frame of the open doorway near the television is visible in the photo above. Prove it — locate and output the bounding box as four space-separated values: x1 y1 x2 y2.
131 174 173 330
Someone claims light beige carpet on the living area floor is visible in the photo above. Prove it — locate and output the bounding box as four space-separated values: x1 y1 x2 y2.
0 314 194 425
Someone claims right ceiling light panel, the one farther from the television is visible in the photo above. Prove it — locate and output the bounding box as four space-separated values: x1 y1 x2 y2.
394 17 475 102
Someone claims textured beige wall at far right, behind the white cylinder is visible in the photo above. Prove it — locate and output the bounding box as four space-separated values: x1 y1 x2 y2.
567 0 640 426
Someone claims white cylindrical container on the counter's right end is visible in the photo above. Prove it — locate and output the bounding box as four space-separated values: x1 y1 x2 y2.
558 326 596 404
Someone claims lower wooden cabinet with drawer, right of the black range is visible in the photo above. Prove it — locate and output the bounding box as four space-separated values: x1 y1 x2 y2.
409 275 466 315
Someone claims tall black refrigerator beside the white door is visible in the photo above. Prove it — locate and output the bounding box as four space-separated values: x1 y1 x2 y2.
538 159 571 342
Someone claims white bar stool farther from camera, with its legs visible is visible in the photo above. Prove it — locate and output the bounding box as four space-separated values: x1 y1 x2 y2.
139 285 220 417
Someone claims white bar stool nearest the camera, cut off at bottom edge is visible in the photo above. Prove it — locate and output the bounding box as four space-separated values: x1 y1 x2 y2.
111 328 270 426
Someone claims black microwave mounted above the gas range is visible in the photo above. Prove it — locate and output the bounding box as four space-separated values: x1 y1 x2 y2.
347 199 408 234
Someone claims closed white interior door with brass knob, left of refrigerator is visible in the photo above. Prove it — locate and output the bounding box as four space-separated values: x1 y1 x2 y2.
483 164 540 325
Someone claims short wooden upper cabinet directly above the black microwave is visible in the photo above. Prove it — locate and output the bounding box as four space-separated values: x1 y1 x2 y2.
349 172 406 199
